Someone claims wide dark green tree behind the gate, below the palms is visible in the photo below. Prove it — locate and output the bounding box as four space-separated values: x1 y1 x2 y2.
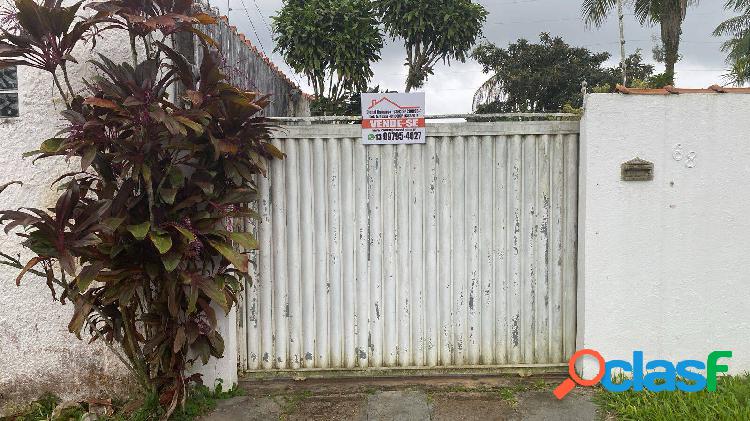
472 33 654 113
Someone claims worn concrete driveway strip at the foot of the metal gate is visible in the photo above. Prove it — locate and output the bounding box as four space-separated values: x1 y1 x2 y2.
203 377 597 421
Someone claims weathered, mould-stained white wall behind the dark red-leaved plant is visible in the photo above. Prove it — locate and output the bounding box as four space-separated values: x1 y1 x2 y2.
0 37 137 408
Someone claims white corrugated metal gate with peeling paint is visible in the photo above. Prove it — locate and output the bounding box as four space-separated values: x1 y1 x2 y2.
240 121 578 370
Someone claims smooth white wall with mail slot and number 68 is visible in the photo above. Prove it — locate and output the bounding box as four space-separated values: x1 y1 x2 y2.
578 94 750 377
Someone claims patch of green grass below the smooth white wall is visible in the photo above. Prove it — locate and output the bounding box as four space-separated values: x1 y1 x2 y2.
594 374 750 421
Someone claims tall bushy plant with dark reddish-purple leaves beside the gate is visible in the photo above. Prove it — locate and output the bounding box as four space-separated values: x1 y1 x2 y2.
0 0 282 416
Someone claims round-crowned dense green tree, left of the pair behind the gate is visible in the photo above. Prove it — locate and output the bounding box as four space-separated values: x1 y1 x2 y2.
273 0 383 102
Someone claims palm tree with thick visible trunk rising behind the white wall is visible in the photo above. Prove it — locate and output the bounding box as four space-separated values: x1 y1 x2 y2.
581 0 704 84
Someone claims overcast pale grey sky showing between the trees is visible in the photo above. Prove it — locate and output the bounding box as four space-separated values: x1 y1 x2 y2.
211 0 731 114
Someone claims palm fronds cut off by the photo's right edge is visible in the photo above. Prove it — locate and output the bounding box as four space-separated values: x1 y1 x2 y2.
714 0 750 86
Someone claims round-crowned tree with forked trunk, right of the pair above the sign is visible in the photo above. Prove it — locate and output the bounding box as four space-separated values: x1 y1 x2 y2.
374 0 487 92
